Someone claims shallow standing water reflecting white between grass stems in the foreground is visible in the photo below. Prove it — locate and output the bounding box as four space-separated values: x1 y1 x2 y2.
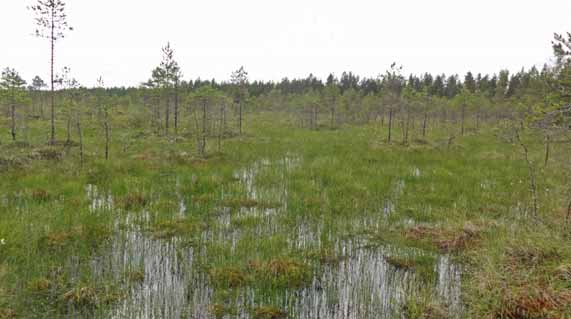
87 156 462 319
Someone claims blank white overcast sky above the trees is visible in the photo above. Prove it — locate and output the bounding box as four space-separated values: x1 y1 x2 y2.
0 0 571 86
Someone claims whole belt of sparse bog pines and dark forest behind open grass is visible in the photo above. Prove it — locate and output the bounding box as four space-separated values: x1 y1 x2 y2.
0 29 571 158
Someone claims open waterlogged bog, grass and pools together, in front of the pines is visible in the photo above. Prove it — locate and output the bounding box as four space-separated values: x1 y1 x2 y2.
0 117 571 319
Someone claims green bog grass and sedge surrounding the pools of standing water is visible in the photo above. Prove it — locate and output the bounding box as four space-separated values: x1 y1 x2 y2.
0 109 571 319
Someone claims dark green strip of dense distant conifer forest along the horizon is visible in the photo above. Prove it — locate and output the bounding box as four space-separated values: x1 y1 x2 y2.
55 64 556 99
